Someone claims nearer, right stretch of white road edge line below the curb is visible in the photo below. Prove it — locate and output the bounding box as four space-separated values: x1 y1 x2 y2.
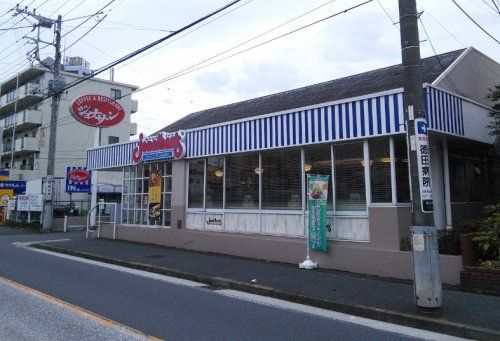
215 289 466 341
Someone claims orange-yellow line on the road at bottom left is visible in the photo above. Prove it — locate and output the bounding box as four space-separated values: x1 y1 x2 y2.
0 276 161 340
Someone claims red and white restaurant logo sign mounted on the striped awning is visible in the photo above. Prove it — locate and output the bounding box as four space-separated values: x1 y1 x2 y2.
132 130 186 163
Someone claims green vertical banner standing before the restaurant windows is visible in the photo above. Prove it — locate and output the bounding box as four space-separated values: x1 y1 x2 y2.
307 174 329 252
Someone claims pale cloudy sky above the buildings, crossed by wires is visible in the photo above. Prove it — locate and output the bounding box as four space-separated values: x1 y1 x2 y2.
0 0 500 134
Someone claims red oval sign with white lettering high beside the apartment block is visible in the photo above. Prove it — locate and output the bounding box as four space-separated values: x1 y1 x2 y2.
70 95 125 128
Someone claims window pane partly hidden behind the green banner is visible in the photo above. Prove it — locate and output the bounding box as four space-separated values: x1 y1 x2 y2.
304 145 333 210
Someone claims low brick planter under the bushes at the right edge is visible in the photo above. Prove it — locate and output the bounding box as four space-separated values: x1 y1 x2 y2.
460 266 500 295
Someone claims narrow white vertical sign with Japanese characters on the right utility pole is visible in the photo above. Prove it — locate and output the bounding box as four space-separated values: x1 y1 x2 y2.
415 118 434 213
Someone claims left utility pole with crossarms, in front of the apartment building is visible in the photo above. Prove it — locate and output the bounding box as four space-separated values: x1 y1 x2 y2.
16 5 65 232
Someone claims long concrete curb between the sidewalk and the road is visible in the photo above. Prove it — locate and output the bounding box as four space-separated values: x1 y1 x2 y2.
29 244 500 340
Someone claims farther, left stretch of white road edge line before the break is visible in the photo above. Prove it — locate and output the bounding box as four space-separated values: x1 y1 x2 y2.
16 242 206 287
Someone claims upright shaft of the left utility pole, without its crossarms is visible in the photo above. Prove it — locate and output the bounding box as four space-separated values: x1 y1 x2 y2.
42 15 62 232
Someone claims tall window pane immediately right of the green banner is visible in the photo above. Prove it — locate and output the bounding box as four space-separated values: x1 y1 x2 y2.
334 143 366 211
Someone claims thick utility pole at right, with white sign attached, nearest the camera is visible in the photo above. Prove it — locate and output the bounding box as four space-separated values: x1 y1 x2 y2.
398 0 442 315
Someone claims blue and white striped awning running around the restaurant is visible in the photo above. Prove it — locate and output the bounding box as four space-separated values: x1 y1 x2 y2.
87 86 464 169
